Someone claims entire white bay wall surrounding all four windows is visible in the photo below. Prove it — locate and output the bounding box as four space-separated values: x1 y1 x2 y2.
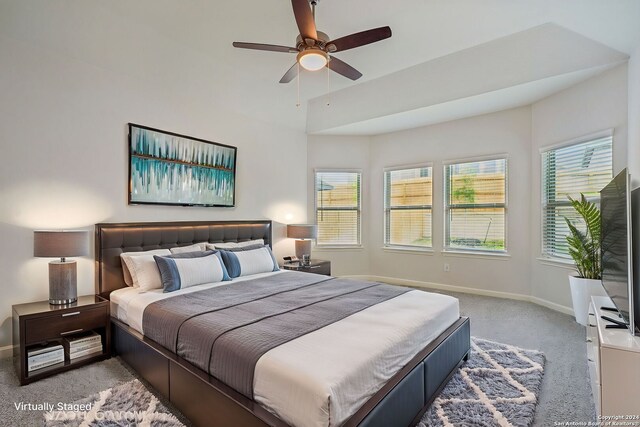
307 64 640 308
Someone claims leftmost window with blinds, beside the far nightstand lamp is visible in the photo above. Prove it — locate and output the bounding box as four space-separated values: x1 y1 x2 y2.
316 171 362 246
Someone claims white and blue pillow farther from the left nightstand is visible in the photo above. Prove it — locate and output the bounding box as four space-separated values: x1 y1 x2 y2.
220 245 280 279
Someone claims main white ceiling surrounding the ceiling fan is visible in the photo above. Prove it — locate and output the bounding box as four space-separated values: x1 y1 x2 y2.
5 0 640 131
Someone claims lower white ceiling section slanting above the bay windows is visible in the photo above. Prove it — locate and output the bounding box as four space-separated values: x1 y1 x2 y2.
307 24 628 135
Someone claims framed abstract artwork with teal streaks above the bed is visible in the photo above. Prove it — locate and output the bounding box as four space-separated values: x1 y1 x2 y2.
129 123 237 207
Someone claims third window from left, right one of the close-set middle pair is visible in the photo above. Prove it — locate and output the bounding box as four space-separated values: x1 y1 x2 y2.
444 159 507 252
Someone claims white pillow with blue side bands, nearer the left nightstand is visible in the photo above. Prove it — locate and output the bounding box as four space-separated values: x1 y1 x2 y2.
153 251 231 292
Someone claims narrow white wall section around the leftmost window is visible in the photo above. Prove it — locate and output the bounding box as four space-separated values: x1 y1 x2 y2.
307 135 372 275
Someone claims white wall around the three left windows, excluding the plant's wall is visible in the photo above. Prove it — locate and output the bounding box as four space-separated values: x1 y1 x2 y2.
307 107 531 295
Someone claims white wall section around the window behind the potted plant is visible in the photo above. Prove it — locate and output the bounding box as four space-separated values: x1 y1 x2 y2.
530 64 627 307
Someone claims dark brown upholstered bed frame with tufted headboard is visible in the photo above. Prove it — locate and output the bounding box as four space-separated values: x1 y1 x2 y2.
95 220 470 427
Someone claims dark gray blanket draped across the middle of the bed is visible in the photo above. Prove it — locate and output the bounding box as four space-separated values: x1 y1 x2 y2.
143 272 410 398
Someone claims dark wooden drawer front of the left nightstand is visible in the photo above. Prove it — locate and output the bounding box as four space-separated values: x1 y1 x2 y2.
24 305 109 345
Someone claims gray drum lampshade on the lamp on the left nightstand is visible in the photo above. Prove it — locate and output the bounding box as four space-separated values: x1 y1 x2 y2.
33 230 89 258
